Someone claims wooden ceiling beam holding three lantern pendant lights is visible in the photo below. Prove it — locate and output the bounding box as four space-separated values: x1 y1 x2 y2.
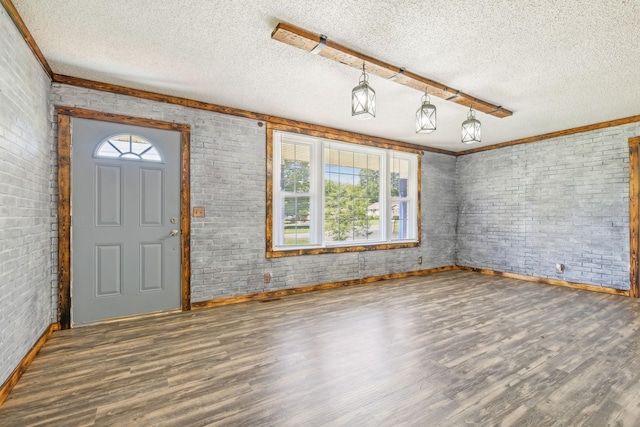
271 22 513 118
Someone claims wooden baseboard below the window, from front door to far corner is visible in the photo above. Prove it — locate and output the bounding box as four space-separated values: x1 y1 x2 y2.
191 265 456 310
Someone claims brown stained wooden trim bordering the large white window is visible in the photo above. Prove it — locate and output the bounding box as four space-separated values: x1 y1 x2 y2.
265 122 422 258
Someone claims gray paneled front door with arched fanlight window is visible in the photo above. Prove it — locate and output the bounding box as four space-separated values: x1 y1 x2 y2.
71 118 181 325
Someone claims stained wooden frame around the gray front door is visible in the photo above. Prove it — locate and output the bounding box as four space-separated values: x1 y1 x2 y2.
56 106 191 329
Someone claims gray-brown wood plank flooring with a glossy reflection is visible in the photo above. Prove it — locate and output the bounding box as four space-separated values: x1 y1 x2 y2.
0 271 640 427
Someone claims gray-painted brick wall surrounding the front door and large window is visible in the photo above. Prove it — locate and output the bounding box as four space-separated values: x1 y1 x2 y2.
52 84 456 312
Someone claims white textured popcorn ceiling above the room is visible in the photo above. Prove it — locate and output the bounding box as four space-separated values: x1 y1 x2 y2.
13 0 640 151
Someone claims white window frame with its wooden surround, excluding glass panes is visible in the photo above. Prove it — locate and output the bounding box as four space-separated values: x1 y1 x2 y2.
266 123 422 258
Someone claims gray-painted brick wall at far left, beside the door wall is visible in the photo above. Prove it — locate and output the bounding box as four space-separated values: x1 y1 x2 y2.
0 7 52 384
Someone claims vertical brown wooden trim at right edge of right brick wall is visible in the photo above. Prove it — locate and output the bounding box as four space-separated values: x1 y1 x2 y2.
629 136 640 298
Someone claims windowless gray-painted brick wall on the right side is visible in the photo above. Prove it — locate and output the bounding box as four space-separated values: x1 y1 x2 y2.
457 123 640 289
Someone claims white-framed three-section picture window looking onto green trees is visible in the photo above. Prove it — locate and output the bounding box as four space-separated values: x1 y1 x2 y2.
267 130 419 256
